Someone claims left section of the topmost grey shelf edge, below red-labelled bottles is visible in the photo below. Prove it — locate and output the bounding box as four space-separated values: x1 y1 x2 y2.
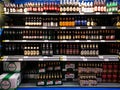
3 12 59 15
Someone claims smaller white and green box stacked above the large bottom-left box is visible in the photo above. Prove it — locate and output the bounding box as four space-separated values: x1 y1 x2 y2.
3 62 25 72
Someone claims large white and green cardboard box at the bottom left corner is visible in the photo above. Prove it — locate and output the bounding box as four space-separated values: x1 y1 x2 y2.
0 73 21 90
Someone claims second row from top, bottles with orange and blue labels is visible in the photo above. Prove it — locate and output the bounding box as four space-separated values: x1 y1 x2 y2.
5 15 120 26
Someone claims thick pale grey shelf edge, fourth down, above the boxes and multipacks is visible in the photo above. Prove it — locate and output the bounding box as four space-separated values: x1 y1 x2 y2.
2 55 119 61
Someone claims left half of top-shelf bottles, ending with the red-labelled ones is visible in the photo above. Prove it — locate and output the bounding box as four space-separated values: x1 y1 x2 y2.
4 1 60 13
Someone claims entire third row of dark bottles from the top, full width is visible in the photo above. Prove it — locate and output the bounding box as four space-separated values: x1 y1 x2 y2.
2 30 119 40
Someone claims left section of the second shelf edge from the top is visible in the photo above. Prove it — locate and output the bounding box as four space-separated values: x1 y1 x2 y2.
2 26 59 29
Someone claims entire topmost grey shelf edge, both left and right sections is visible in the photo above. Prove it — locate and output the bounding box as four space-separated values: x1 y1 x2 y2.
3 12 120 15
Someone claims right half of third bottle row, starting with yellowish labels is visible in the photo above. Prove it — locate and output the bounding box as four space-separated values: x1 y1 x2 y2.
57 30 116 40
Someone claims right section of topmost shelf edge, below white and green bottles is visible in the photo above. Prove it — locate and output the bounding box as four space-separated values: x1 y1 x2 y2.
60 12 119 15
